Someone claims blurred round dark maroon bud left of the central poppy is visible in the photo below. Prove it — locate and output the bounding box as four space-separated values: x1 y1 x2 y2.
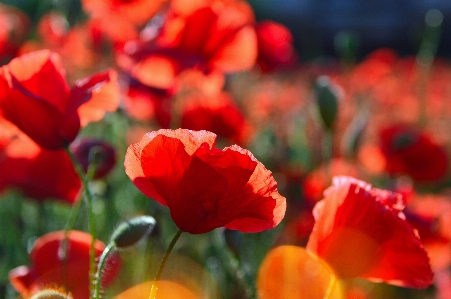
71 139 116 179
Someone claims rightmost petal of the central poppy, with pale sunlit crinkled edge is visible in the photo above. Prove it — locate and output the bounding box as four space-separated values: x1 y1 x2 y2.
226 146 286 232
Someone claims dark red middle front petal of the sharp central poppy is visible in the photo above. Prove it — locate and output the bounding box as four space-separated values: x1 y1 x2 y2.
167 147 256 234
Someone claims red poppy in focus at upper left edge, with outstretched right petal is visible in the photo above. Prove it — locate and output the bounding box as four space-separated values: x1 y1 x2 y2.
0 50 118 149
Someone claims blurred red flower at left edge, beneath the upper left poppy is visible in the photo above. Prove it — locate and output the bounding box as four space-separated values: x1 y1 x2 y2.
0 118 81 203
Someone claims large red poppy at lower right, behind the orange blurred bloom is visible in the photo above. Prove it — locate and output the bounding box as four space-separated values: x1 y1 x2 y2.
307 177 433 288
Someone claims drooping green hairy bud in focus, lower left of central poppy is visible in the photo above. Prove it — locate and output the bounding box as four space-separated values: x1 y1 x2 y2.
111 216 156 248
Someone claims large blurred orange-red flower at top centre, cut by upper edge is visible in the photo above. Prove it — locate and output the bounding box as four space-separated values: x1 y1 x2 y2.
117 0 257 89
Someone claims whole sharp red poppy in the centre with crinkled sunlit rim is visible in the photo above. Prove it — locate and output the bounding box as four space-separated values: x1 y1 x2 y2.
125 129 286 234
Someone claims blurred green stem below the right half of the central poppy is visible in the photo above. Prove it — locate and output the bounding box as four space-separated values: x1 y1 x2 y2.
212 229 256 298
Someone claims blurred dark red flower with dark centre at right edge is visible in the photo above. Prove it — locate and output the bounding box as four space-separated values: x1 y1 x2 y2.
379 124 449 182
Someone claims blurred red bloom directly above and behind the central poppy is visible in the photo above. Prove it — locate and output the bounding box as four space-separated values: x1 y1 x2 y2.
124 71 252 144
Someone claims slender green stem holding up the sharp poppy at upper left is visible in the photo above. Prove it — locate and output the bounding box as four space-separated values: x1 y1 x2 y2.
65 146 96 294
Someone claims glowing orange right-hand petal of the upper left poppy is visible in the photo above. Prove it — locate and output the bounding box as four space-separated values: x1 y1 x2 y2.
76 69 120 126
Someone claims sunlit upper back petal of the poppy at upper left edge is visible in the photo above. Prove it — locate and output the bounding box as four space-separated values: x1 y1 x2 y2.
4 50 69 114
